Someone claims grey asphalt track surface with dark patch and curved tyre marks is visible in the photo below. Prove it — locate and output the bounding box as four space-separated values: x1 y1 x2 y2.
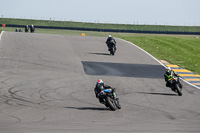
0 32 200 133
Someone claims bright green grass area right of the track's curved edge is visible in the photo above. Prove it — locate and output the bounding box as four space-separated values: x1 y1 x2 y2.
119 35 200 74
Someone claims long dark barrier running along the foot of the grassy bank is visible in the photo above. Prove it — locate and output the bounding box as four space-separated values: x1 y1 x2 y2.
1 24 200 35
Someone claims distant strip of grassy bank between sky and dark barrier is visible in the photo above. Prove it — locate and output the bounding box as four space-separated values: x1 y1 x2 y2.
0 18 200 32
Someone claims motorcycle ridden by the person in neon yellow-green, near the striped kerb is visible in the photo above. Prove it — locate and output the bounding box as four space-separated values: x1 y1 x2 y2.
171 77 182 96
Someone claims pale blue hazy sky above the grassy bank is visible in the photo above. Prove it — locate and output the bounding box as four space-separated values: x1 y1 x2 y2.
0 0 200 26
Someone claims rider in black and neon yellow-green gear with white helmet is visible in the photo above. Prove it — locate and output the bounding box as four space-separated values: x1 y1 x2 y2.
164 67 182 88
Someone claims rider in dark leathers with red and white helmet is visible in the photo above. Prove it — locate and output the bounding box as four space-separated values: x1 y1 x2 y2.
94 79 120 106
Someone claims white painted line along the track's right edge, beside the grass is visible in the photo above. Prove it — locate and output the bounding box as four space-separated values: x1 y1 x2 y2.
117 38 200 89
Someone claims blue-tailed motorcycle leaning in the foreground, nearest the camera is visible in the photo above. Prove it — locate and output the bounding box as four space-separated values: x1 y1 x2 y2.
99 89 121 111
